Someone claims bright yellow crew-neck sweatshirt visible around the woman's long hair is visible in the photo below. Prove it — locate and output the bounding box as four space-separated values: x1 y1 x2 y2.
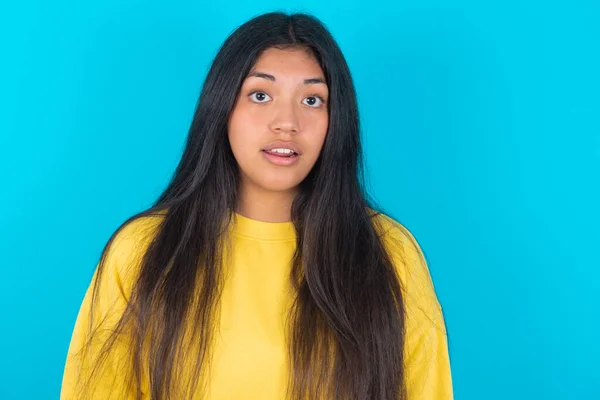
61 214 453 400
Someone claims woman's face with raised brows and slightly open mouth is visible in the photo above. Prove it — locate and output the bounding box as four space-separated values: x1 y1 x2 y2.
228 48 329 195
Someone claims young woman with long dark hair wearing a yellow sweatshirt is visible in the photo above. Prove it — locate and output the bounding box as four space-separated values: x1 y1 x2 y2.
61 13 452 400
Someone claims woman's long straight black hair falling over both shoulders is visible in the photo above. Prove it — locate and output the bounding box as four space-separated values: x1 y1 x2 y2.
77 12 406 400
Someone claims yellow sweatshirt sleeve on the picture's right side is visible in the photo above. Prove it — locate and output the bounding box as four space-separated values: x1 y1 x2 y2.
388 216 453 400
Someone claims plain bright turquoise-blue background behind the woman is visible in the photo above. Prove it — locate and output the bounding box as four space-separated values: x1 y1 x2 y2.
0 0 600 400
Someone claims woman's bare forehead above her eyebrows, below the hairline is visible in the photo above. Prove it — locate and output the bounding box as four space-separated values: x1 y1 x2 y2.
250 48 324 80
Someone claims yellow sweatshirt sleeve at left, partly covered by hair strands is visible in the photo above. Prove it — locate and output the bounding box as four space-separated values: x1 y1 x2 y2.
60 219 152 400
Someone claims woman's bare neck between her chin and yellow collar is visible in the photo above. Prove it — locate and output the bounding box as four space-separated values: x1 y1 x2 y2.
235 180 298 222
